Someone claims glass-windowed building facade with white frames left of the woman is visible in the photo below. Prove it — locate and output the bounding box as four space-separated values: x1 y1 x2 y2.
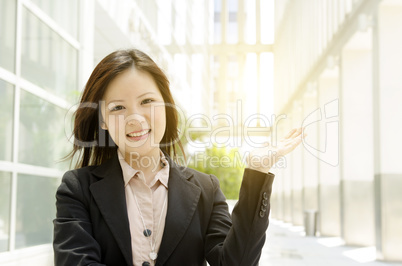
0 0 84 265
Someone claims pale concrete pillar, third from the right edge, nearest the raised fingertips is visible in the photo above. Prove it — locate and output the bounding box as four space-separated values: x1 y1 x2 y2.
318 67 341 236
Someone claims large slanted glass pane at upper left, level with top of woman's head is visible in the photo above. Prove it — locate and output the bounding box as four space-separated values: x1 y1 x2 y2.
21 9 78 101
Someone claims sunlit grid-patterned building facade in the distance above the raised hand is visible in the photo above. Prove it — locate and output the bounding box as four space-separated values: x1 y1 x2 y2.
211 0 274 133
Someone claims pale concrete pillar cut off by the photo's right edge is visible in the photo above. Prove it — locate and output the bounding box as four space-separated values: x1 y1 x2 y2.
373 0 402 261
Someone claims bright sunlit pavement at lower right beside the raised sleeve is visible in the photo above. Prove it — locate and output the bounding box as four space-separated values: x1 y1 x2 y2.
228 201 402 266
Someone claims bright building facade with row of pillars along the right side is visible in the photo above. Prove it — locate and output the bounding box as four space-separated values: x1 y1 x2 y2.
272 0 402 261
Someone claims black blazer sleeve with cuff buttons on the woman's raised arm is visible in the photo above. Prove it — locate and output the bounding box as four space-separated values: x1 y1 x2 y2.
205 168 274 266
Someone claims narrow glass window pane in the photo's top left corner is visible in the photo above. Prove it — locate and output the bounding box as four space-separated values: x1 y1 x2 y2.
0 0 17 72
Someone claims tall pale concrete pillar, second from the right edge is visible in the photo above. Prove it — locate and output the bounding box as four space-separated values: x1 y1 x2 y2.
340 31 374 246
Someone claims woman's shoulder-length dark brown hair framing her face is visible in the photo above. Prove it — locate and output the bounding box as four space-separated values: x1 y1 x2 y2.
66 49 184 168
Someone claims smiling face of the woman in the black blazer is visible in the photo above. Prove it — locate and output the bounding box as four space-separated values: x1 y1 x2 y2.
101 67 166 161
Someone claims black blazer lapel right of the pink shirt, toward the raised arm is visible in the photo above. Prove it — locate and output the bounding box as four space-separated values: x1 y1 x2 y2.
156 159 201 265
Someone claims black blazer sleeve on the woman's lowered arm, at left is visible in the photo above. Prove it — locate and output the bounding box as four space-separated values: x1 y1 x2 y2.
53 171 104 266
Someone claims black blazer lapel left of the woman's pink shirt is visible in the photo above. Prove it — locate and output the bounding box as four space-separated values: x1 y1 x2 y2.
89 153 133 265
